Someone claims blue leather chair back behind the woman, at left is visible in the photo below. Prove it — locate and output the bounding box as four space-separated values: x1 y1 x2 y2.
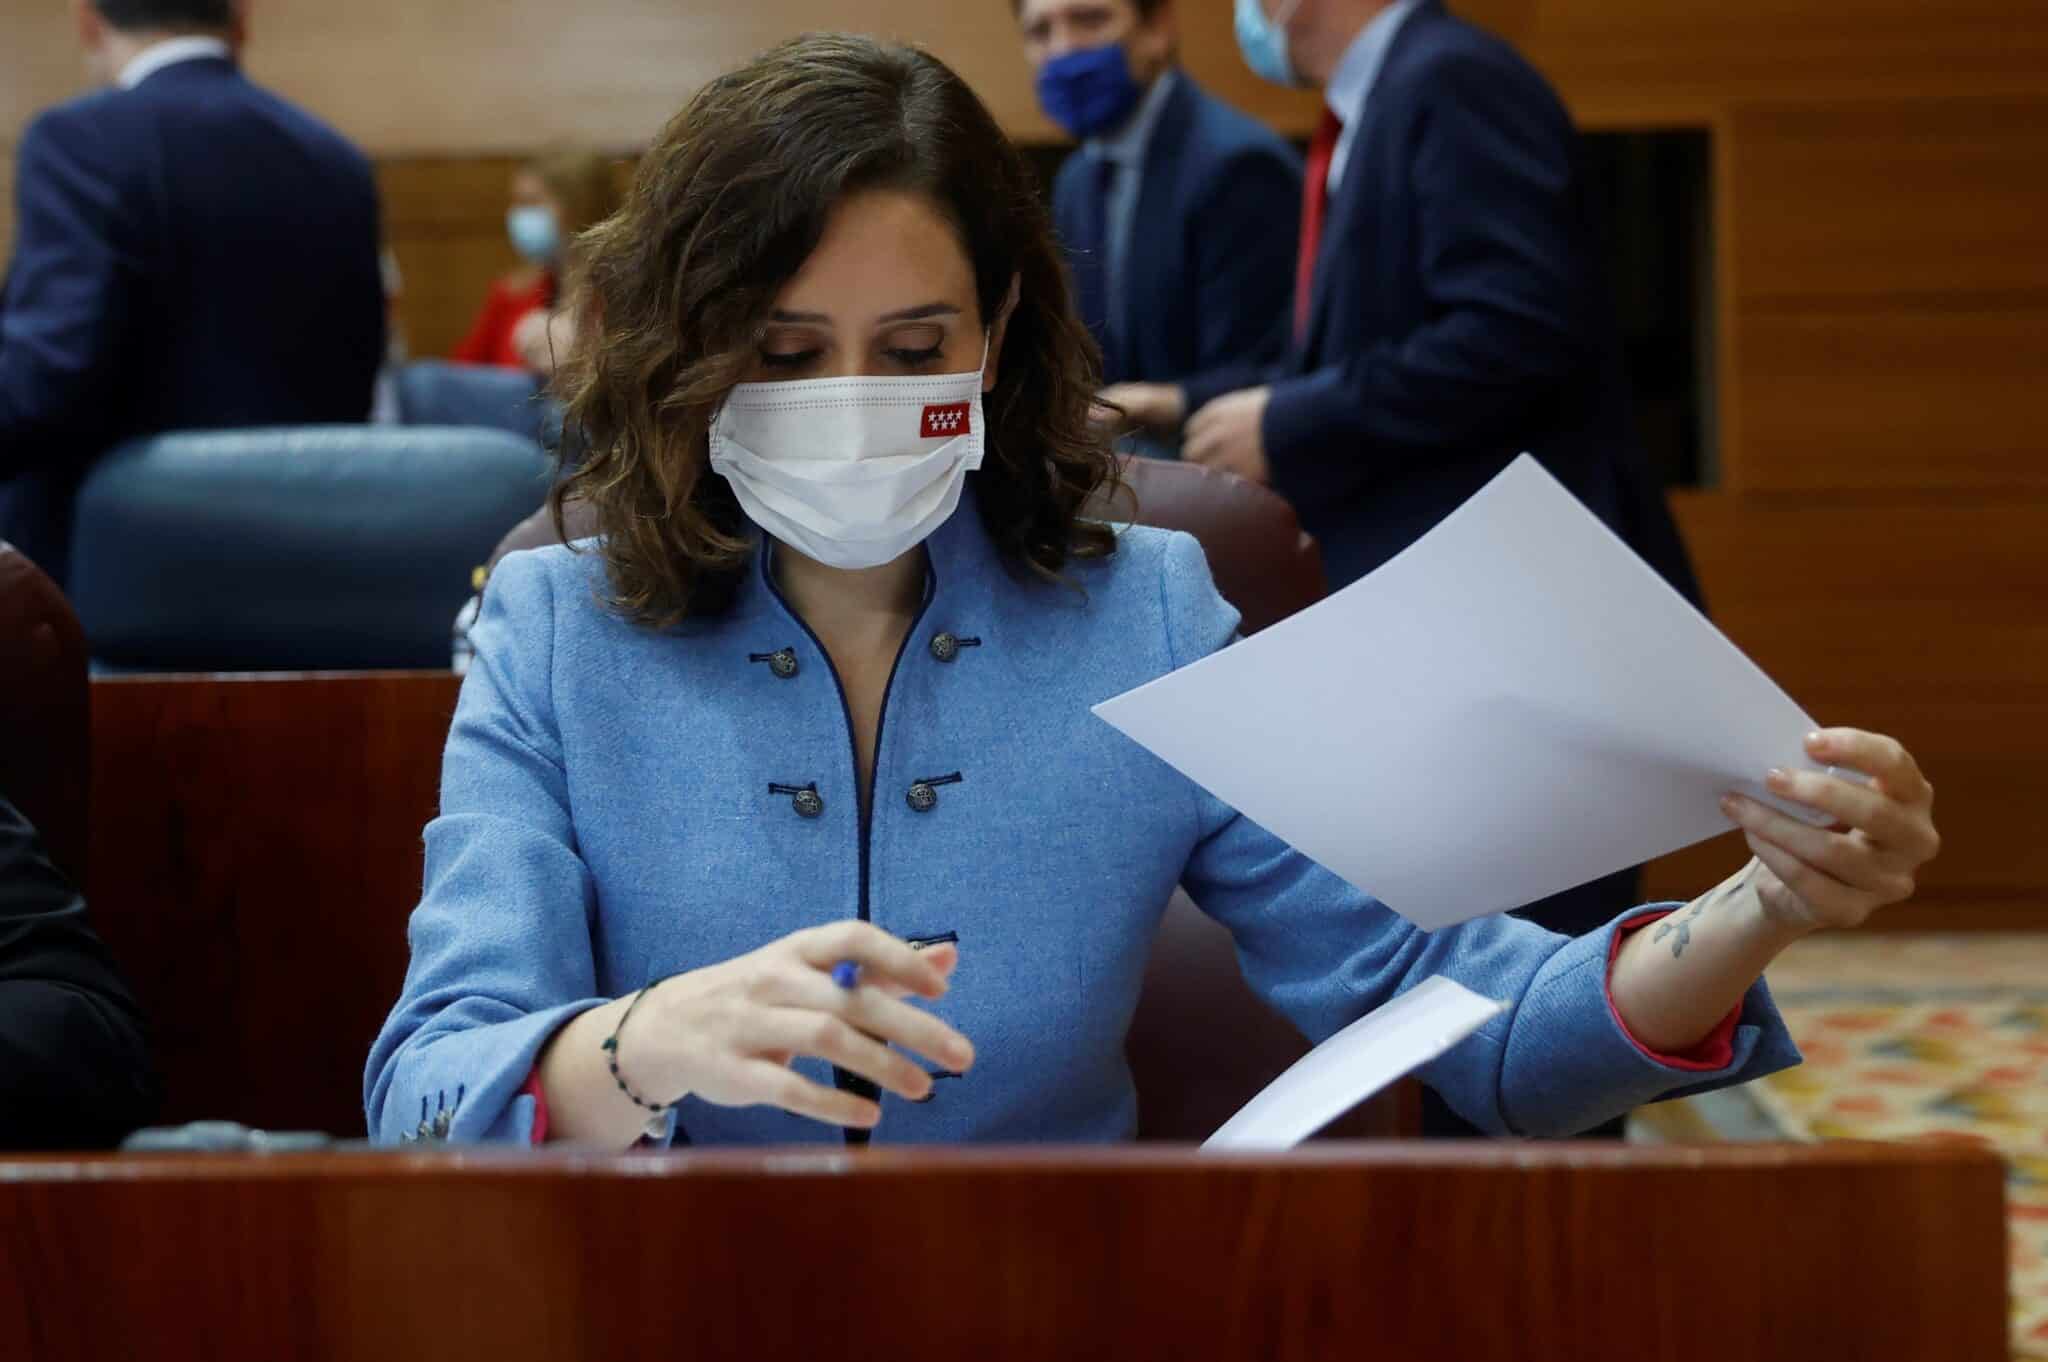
72 426 549 672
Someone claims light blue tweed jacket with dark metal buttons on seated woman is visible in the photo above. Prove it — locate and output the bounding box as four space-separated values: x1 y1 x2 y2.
365 483 1798 1145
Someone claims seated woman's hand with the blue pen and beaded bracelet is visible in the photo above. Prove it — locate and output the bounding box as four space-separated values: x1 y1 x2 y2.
616 922 975 1126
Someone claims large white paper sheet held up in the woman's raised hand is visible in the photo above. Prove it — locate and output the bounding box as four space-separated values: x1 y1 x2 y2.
1096 455 1843 928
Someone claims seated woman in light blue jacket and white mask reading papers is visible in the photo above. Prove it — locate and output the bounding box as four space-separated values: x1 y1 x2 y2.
365 37 1935 1147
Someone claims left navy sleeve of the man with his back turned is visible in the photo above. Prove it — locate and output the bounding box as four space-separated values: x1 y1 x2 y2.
0 115 139 466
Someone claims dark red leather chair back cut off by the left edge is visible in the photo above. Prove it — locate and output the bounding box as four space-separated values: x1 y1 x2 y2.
0 543 92 885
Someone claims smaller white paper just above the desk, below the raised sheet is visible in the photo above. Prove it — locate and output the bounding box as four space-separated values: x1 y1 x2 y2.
1202 975 1507 1149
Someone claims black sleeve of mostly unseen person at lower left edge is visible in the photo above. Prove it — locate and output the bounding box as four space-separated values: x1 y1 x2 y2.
0 799 156 1149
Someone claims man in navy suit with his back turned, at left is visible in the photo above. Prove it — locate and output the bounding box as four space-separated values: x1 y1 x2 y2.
0 0 385 582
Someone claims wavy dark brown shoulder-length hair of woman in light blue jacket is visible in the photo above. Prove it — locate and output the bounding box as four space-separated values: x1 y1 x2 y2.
551 35 1116 629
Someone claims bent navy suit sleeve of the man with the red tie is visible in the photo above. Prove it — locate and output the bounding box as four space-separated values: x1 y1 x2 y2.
1264 59 1599 502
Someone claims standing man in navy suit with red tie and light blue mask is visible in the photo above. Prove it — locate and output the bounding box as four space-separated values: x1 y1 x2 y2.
1151 0 1698 596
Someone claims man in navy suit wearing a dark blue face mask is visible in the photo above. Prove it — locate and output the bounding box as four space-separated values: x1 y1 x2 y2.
1014 0 1300 453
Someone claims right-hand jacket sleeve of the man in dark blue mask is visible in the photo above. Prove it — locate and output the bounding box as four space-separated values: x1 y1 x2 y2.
1184 147 1300 401
